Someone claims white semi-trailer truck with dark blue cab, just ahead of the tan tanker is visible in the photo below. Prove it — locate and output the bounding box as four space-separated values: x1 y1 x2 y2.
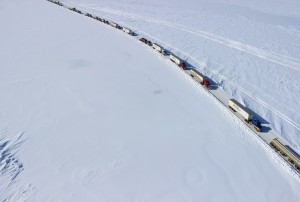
229 99 261 132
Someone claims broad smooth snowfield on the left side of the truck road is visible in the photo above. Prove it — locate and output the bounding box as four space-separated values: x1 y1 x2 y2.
0 0 300 202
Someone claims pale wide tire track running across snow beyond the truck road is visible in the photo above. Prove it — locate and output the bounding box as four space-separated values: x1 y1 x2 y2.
74 3 300 71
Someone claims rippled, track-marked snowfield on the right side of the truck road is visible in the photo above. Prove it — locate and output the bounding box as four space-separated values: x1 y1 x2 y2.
61 0 300 152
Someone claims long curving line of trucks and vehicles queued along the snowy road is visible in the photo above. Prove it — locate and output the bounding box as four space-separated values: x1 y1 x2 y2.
47 0 300 173
